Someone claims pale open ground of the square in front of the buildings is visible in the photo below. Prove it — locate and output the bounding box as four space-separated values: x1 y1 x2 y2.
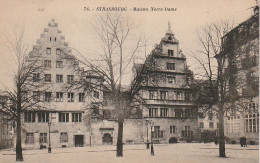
0 143 259 163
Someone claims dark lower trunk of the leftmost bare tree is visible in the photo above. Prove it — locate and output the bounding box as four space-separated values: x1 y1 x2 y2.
16 112 23 161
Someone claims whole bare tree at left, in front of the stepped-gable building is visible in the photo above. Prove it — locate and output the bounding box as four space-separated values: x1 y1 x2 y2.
0 30 51 161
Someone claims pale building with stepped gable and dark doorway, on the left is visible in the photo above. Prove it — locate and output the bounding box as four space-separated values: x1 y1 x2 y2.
18 20 102 148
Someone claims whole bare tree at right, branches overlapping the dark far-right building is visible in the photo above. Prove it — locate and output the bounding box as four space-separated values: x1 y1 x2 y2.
192 21 258 157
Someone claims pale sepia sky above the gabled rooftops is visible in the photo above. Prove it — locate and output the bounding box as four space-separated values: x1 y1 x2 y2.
0 0 256 89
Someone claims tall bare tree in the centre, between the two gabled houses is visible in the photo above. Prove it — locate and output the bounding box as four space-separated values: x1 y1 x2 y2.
69 13 141 157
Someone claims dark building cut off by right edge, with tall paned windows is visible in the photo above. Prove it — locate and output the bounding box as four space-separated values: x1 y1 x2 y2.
222 6 259 144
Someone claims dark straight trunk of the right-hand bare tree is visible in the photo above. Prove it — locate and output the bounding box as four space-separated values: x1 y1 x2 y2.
219 104 226 157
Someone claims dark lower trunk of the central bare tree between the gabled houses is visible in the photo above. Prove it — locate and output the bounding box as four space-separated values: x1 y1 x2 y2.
116 118 124 157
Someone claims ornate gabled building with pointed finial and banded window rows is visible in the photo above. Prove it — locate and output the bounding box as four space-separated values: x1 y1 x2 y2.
136 23 198 143
